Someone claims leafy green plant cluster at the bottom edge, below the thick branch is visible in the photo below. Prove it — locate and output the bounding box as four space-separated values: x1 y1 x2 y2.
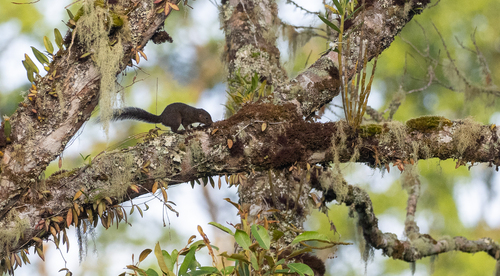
121 202 346 276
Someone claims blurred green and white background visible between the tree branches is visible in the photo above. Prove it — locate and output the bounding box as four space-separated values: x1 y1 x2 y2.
0 0 500 275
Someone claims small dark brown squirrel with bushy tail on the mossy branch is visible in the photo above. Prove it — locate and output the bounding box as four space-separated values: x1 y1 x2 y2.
111 103 212 133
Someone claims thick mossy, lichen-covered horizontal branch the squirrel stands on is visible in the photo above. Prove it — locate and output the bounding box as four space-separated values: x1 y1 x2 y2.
4 104 500 256
